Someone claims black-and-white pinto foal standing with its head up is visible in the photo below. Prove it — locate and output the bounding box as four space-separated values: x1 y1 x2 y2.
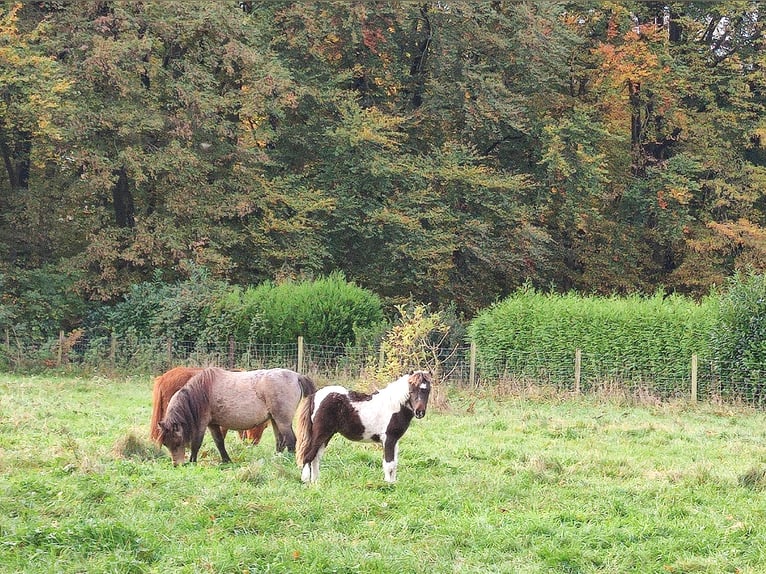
296 371 433 482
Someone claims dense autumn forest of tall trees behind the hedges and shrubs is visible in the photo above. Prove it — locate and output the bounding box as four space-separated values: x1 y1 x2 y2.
0 0 766 332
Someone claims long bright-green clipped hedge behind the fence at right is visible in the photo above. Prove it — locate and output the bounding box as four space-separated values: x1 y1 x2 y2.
468 288 715 382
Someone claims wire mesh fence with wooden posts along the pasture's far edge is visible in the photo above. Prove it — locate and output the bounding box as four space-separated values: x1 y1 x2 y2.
0 334 766 408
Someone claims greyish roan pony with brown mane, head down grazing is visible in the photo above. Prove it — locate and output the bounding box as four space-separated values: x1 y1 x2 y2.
158 367 316 465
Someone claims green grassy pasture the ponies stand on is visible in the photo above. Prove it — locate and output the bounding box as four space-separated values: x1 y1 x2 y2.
0 374 766 574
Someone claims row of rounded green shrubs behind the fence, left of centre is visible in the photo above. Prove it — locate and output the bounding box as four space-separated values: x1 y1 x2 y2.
105 269 383 346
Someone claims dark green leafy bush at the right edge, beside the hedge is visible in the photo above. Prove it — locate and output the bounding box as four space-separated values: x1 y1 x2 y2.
710 272 766 392
